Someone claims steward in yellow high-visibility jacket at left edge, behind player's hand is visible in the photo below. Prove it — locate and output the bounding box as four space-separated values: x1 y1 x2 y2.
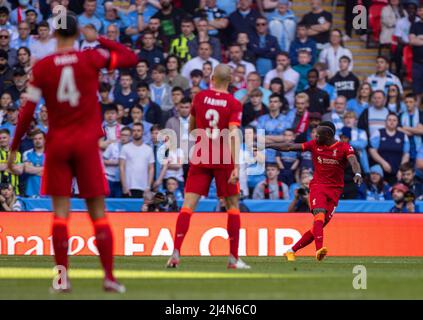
0 129 23 195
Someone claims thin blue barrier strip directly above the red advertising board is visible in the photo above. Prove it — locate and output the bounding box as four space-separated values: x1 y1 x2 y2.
16 198 423 213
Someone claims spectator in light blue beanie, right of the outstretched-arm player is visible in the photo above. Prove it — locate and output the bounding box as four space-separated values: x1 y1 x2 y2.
359 164 392 201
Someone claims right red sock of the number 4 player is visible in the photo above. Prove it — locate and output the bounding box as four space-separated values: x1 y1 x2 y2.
93 217 115 281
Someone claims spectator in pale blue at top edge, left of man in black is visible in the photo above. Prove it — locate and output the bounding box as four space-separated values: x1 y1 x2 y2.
267 0 297 51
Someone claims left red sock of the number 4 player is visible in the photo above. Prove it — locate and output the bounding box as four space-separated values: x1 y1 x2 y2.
52 217 69 269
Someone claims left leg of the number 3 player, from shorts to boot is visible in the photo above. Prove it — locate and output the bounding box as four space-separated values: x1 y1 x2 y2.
166 166 212 268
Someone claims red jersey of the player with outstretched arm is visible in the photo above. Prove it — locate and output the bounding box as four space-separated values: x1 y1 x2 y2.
302 139 354 188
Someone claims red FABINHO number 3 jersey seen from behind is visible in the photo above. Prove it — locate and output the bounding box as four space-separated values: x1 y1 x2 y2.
191 90 242 168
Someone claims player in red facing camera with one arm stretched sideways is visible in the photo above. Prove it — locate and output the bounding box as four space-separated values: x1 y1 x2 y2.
266 121 362 261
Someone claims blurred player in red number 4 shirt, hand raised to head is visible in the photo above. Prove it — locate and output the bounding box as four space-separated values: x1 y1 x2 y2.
8 14 137 292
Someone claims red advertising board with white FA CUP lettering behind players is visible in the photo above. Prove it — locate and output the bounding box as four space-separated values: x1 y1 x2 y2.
0 212 423 256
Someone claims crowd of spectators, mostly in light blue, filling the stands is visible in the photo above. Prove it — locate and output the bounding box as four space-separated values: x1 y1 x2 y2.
0 0 423 212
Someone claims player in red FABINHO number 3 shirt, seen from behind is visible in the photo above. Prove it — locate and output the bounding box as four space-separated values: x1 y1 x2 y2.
167 64 250 269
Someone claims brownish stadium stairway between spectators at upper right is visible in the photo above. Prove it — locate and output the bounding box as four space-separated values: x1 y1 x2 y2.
291 0 378 80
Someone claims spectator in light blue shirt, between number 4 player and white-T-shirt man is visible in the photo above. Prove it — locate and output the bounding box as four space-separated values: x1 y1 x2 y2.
103 127 131 198
